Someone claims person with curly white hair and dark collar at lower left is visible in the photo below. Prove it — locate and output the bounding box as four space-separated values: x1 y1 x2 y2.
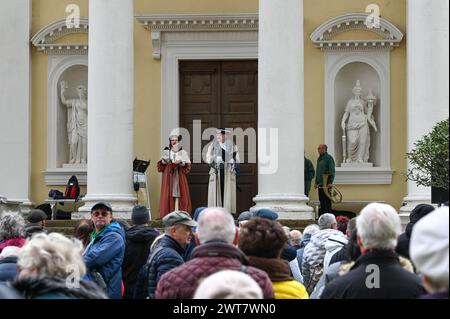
13 233 107 299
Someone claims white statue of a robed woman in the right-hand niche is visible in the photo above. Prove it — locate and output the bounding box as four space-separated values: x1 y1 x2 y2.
341 80 378 166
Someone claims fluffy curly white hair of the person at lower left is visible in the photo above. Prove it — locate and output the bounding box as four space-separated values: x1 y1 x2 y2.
17 233 86 278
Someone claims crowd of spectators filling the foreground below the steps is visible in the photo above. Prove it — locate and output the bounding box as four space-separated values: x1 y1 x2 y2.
0 202 449 299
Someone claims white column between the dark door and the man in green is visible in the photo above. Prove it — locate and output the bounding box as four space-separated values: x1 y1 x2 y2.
252 0 313 219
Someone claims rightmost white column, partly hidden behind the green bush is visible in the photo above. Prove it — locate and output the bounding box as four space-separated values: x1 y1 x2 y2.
400 0 449 223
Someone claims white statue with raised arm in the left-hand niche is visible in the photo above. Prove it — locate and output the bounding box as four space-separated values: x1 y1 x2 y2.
60 81 88 164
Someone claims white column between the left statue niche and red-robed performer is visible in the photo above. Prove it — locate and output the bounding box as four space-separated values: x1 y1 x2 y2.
80 0 136 217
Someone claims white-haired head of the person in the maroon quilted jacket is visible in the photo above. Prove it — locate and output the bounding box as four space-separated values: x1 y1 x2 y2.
197 207 236 244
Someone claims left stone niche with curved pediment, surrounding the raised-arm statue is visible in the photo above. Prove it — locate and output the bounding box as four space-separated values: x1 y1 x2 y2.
31 17 89 185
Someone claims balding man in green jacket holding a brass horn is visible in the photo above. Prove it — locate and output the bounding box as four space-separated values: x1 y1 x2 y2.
315 144 335 216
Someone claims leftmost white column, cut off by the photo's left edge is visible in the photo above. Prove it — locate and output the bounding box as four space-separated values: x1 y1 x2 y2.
0 0 31 215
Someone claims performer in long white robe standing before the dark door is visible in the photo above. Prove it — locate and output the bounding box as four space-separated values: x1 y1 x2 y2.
206 128 240 214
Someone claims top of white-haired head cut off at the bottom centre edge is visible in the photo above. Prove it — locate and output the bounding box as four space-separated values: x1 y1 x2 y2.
194 270 263 299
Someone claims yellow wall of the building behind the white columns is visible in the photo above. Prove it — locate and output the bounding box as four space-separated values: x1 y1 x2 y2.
31 0 406 217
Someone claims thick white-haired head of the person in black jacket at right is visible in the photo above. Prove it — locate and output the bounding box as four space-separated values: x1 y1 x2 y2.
356 203 401 249
